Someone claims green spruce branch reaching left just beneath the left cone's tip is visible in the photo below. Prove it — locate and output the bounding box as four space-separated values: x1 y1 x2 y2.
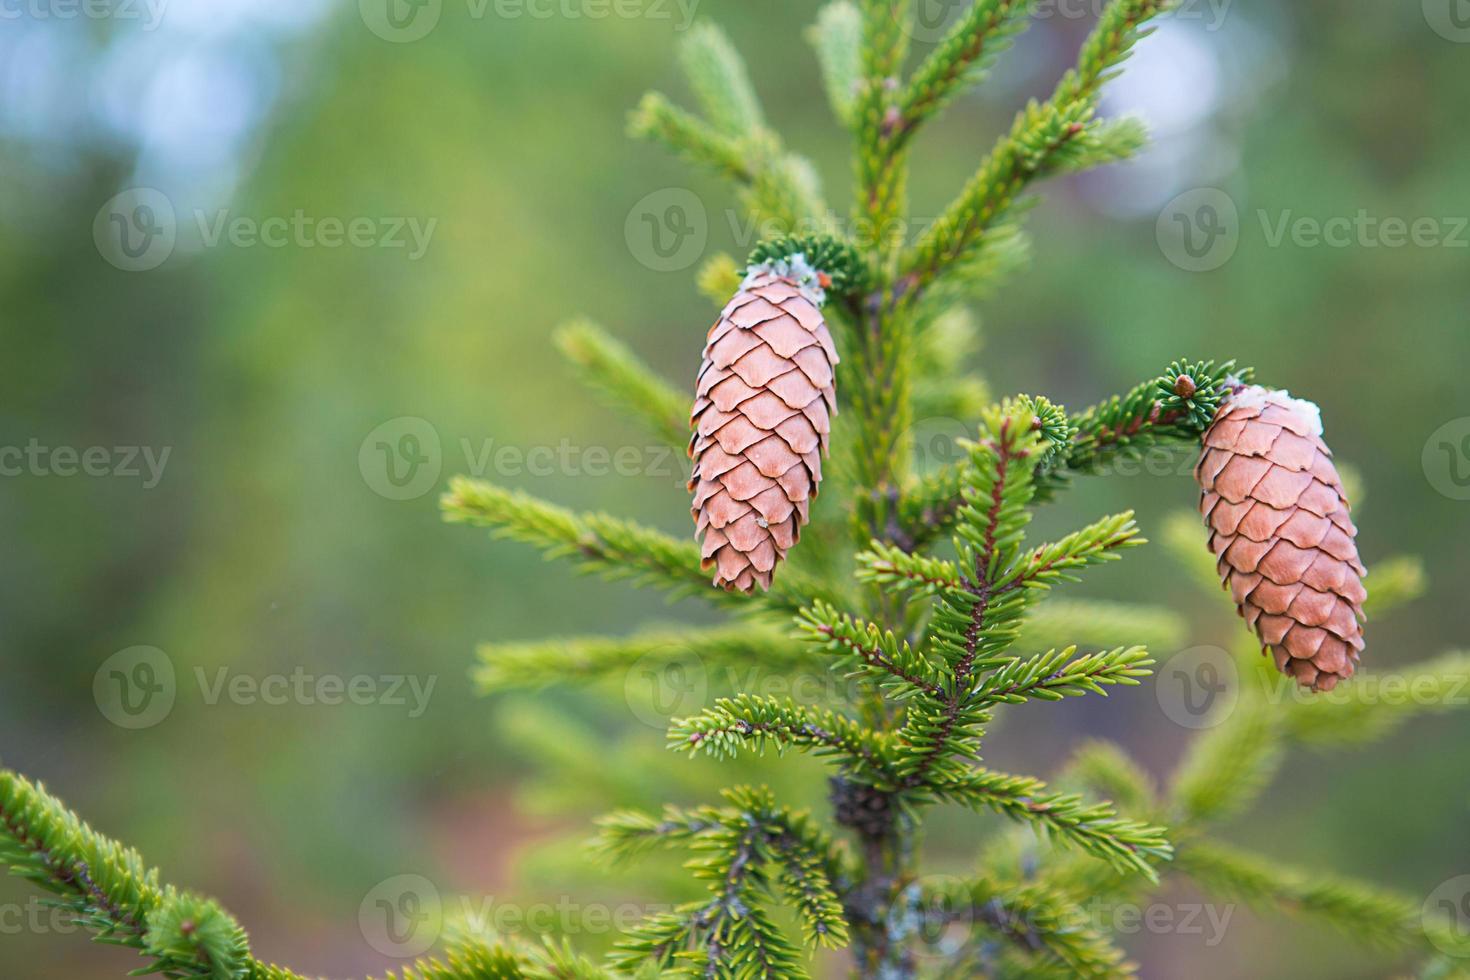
441 476 832 613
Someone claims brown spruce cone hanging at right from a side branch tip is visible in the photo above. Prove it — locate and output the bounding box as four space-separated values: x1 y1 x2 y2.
1195 385 1367 691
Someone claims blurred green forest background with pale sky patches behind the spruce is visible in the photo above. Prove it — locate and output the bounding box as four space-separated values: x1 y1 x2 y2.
0 0 1470 979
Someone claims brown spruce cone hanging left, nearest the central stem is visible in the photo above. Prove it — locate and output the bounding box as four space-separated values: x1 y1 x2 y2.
689 254 838 592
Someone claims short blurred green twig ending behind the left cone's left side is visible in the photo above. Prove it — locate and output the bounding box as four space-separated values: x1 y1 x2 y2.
553 319 689 450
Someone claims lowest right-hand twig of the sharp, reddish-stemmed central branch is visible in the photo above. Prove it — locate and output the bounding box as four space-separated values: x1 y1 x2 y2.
923 768 1173 883
